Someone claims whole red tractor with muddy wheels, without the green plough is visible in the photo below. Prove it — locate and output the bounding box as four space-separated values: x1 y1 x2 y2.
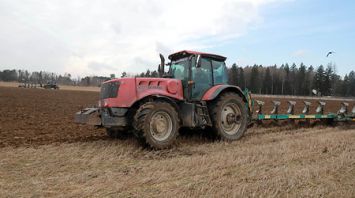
75 51 251 149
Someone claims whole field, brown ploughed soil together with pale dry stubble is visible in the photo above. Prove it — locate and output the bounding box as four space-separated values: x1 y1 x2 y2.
0 87 355 197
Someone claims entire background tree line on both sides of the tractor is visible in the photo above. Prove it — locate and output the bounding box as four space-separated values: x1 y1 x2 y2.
0 63 355 96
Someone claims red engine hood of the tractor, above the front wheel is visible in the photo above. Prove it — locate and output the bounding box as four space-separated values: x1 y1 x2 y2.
99 78 184 107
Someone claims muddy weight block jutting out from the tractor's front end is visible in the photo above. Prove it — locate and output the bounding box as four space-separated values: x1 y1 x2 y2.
74 108 102 126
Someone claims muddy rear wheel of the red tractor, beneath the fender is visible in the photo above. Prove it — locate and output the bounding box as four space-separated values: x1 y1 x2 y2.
210 93 249 141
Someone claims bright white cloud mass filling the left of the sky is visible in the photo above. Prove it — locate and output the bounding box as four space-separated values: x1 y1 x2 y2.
0 0 288 75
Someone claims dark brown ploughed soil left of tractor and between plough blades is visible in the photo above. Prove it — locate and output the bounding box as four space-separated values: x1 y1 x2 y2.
0 87 353 147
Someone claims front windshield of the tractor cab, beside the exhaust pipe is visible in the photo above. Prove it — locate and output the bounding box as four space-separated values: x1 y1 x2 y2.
170 57 189 80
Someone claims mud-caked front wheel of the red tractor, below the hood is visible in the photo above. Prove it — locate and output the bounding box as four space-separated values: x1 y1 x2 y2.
133 102 179 149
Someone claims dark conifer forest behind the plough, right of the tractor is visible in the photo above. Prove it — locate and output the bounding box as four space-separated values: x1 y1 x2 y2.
228 63 355 96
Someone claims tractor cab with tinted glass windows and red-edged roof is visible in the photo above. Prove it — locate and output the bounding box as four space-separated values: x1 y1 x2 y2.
159 51 228 101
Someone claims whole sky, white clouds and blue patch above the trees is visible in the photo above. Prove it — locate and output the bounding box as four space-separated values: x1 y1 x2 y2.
0 0 355 77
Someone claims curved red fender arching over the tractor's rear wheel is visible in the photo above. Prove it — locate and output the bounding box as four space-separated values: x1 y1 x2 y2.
202 85 248 102
